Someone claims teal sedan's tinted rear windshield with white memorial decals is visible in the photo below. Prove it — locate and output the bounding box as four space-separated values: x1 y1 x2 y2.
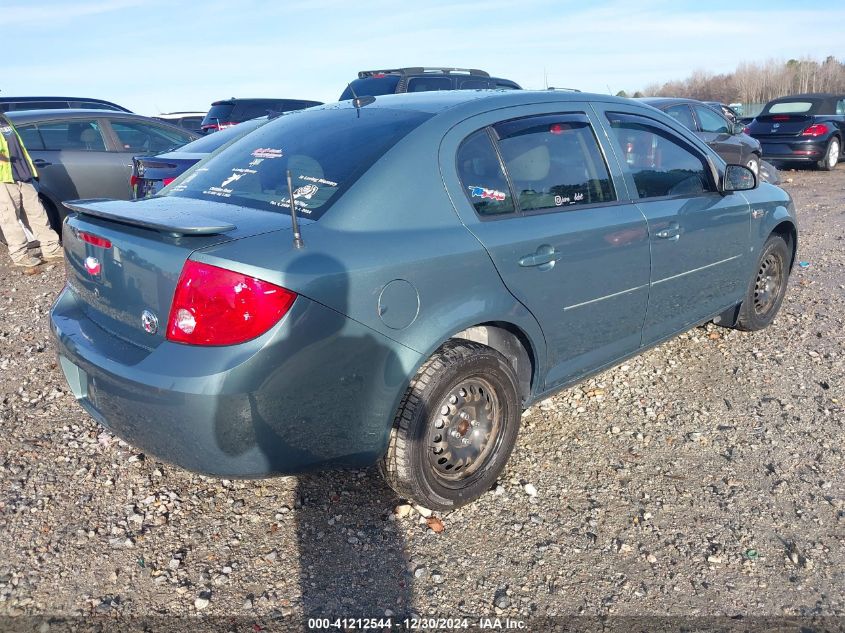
166 108 432 220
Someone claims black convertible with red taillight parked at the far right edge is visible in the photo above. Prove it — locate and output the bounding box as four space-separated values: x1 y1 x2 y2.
746 93 845 171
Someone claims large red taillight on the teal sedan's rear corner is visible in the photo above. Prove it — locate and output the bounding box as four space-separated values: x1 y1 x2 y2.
167 261 296 345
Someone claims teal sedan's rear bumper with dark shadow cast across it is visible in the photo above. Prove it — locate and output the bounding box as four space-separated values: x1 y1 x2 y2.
51 288 419 478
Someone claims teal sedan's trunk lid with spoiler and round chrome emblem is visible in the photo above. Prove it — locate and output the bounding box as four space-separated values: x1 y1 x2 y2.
63 197 296 350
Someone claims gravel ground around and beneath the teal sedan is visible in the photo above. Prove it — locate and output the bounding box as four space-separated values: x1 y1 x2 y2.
0 167 845 630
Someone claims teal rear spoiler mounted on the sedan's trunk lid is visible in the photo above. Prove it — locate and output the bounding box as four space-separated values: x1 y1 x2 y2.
64 198 237 236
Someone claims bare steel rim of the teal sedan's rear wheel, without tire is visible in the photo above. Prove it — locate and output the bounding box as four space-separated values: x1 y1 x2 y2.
428 376 502 483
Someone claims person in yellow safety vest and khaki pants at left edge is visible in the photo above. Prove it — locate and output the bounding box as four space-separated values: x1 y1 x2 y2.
0 114 64 268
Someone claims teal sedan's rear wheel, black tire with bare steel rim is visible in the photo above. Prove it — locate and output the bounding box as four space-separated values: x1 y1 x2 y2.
381 339 522 510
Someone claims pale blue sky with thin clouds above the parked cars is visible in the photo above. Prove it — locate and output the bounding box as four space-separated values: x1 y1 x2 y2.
0 0 845 115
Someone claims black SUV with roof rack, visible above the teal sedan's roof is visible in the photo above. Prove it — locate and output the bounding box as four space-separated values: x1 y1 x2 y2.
340 67 521 101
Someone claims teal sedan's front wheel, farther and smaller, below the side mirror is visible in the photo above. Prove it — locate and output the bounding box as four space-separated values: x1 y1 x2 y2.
734 235 792 332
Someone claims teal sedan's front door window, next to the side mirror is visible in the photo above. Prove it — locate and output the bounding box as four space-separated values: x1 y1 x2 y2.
607 112 716 198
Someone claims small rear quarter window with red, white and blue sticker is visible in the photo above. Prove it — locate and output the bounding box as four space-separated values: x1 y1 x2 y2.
457 128 514 216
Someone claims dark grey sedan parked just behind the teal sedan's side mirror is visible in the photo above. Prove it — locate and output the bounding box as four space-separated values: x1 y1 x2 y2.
640 97 763 174
